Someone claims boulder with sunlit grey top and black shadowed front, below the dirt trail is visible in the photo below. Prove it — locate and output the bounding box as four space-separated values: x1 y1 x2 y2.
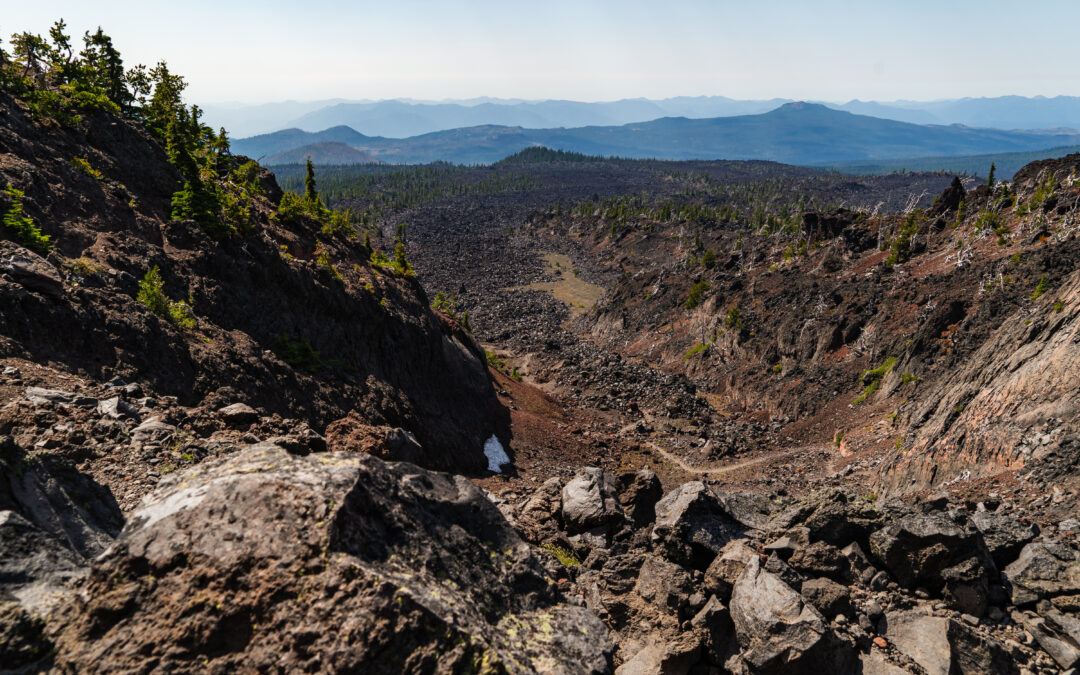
652 481 744 570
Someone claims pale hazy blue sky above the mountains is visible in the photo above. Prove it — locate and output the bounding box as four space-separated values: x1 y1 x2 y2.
8 0 1080 103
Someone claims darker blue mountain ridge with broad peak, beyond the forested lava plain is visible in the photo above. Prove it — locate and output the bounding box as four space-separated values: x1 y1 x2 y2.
233 103 1080 165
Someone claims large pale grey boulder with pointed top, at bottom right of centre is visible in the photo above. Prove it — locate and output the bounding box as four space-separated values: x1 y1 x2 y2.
731 556 854 674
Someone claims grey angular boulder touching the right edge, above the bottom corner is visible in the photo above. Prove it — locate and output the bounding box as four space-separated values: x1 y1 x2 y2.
1004 541 1080 606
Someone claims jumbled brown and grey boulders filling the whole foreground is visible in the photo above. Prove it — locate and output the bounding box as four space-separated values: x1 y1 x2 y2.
0 388 1080 674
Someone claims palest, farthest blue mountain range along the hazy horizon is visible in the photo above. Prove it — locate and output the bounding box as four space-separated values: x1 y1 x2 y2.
204 96 1080 138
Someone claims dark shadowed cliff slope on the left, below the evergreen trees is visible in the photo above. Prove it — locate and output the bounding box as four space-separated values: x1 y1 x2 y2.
0 89 509 472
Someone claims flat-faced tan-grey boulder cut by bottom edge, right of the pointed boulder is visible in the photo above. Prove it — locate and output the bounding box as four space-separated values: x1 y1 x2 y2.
886 611 1017 675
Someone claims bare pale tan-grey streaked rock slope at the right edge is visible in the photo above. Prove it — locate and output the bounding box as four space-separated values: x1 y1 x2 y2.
881 272 1080 492
